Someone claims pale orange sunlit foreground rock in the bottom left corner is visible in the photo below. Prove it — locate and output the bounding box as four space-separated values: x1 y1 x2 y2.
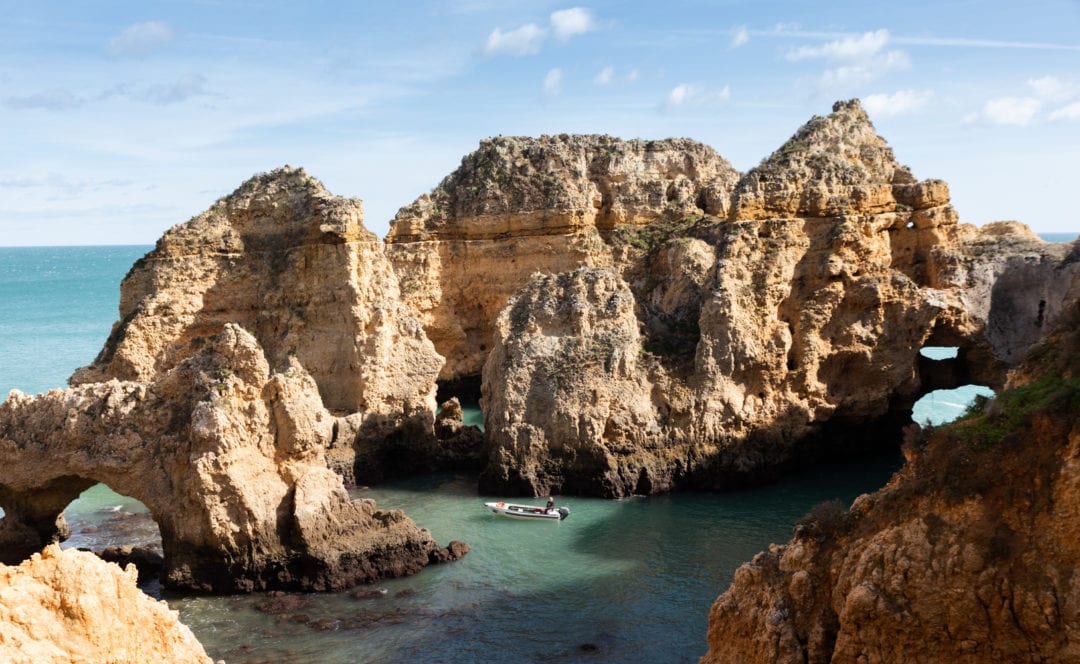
0 545 212 664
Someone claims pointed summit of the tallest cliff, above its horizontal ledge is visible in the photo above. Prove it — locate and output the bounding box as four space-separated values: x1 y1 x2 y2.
731 99 948 220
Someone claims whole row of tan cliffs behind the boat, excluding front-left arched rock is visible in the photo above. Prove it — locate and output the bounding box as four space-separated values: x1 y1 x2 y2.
38 100 1080 509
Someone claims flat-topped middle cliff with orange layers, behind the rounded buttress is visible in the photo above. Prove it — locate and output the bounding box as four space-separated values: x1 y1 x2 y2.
387 134 739 380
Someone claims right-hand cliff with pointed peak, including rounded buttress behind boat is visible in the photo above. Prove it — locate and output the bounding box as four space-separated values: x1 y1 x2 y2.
484 101 989 496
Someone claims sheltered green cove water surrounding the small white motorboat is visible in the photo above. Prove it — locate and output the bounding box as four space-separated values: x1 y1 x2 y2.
159 456 900 663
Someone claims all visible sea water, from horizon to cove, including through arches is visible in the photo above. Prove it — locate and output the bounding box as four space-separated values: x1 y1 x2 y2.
0 233 1077 664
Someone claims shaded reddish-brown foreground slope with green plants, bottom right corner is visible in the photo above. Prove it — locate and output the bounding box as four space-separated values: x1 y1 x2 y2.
702 303 1080 664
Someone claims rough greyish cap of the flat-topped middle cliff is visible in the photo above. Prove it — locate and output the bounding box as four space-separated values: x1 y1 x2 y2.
387 134 739 243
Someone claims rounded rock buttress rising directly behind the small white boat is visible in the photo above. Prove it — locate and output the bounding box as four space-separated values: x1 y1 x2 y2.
481 268 667 496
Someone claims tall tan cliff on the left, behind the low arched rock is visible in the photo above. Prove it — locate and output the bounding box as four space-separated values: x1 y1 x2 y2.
71 166 443 442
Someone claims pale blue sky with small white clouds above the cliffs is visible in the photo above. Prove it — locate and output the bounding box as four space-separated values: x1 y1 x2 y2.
0 0 1080 246
